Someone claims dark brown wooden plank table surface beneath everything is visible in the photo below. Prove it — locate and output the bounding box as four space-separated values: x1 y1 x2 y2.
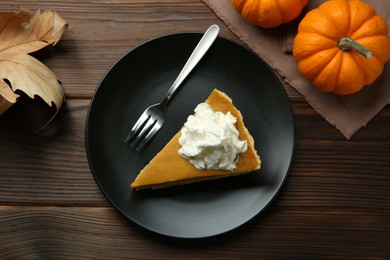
0 0 390 259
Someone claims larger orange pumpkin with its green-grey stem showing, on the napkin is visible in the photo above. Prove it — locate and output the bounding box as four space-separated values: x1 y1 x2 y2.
293 0 390 95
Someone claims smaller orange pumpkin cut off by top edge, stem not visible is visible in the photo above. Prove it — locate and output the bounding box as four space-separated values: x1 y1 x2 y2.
232 0 309 28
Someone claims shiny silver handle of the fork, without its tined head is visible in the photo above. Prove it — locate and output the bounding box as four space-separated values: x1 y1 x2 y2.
161 24 219 105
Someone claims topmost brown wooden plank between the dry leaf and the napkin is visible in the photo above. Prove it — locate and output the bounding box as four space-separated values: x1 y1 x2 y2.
2 0 234 98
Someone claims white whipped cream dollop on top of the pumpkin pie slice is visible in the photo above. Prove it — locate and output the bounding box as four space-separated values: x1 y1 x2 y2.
179 103 248 171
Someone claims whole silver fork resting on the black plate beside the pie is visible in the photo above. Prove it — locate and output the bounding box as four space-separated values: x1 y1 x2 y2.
125 24 219 150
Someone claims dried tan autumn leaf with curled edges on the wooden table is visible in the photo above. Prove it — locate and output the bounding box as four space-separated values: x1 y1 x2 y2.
0 8 68 123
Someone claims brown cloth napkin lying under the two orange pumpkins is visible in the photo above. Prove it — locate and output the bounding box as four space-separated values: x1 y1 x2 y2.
202 0 390 139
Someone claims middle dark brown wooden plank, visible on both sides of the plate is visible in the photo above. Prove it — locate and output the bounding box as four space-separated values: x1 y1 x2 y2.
0 99 390 212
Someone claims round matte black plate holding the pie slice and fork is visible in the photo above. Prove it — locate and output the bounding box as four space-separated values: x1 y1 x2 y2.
86 33 294 238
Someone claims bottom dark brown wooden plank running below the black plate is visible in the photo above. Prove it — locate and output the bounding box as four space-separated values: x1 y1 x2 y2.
0 206 390 259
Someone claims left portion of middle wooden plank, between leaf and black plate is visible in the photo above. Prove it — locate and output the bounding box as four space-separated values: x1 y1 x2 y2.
0 100 107 205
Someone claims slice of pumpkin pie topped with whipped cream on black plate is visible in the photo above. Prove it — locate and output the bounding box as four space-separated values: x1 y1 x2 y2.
131 89 261 190
